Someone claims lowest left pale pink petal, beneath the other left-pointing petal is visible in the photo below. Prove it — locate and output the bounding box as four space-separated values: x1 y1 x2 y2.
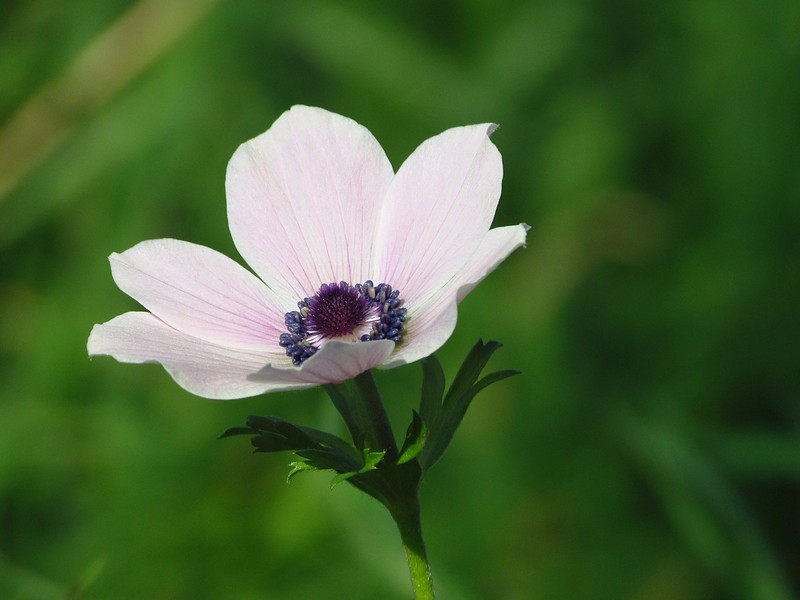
87 312 312 400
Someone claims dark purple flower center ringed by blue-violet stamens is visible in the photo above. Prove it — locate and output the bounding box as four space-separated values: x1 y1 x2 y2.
279 280 406 365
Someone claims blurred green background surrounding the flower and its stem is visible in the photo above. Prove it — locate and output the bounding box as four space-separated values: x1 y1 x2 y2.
0 0 800 600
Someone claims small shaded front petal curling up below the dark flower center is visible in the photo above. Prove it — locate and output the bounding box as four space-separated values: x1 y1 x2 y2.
251 340 395 384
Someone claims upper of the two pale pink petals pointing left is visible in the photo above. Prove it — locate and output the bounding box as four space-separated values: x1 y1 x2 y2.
109 239 291 352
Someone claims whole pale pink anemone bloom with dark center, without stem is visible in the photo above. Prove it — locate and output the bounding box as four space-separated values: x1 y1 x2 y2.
88 106 527 399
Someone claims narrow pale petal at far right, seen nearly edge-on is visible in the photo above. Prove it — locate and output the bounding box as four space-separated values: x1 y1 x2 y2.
381 224 529 368
